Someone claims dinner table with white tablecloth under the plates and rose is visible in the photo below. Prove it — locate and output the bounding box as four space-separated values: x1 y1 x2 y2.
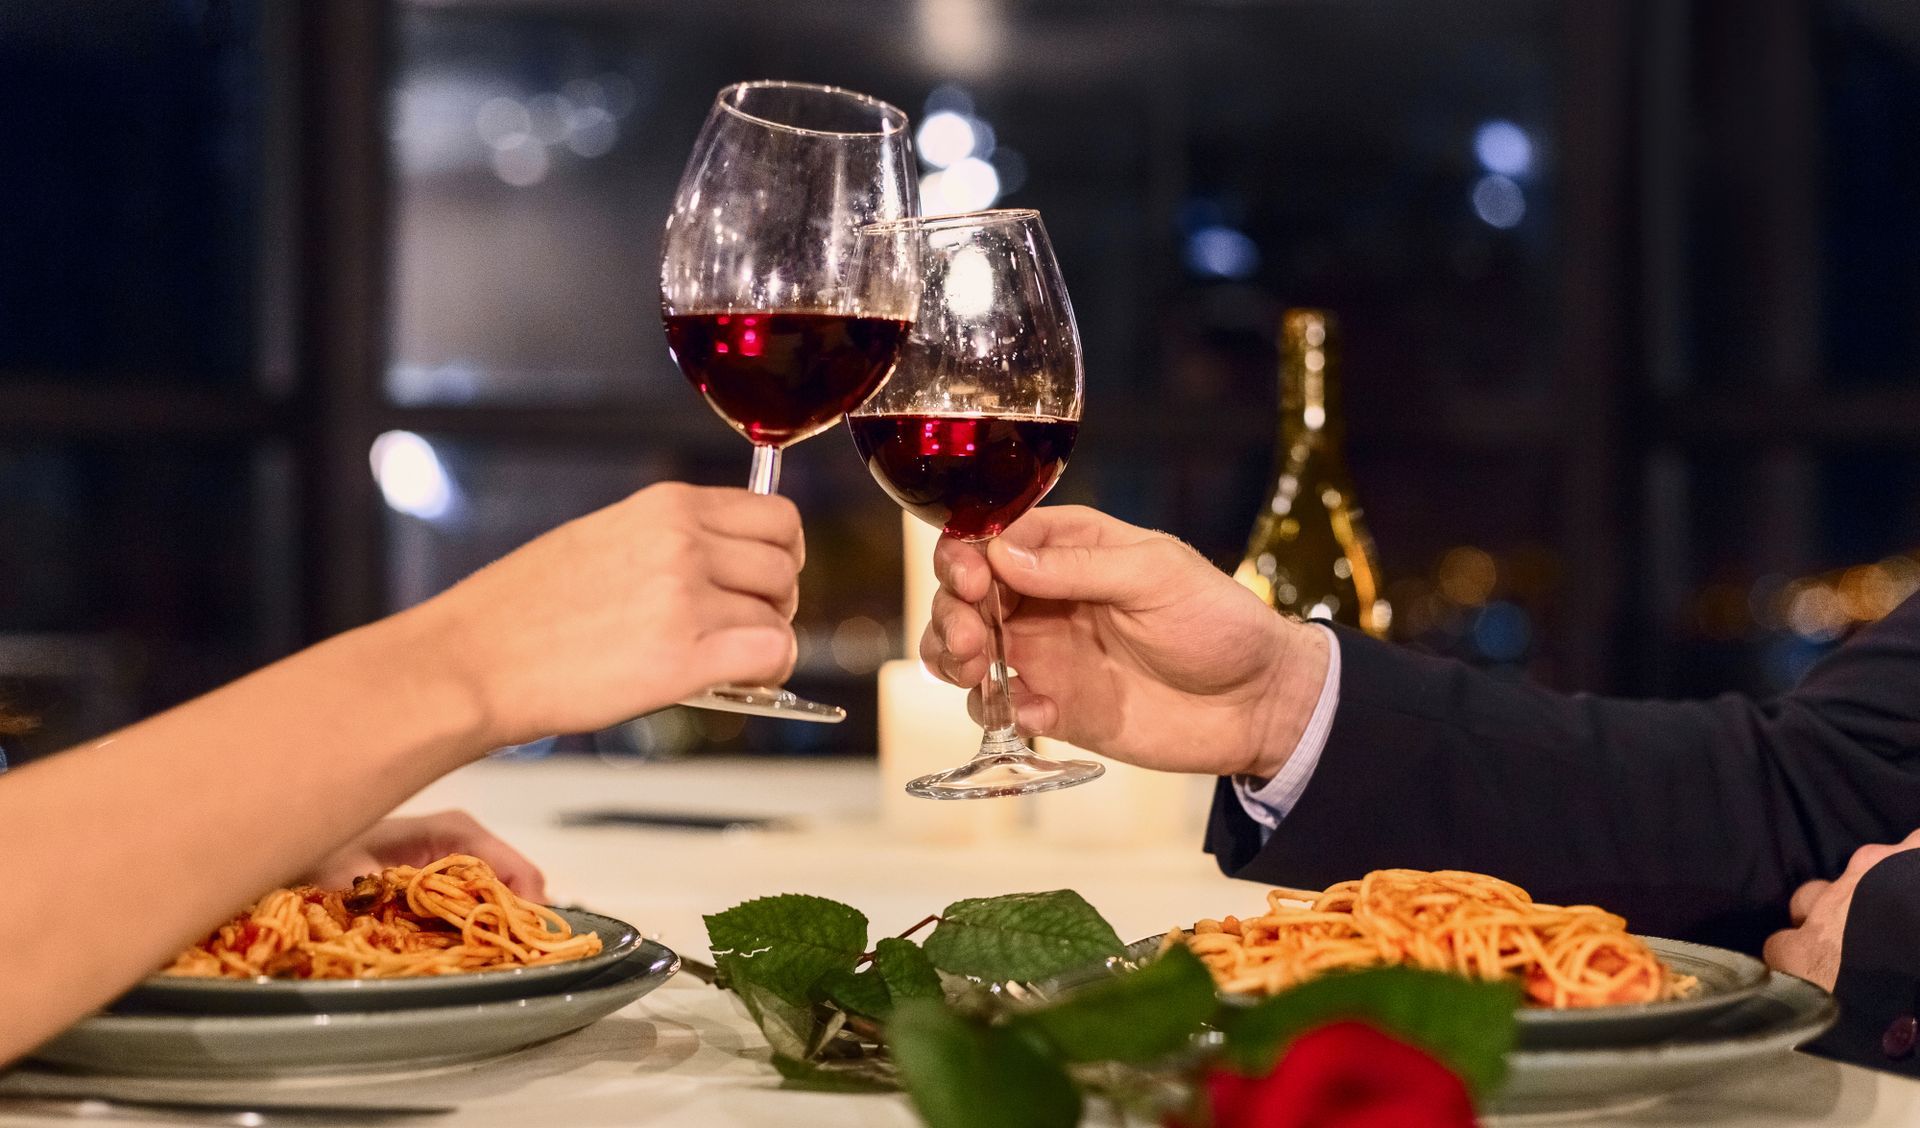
11 756 1920 1128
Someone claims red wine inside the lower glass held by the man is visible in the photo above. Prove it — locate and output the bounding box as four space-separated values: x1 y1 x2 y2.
847 414 1079 541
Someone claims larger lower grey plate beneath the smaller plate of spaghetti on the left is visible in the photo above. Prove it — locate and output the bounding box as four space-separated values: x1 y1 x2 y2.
31 940 680 1078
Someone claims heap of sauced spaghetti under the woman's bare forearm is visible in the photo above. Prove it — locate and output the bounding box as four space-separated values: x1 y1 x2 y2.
161 854 601 978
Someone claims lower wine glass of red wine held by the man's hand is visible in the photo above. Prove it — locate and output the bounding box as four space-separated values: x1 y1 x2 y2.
847 209 1104 800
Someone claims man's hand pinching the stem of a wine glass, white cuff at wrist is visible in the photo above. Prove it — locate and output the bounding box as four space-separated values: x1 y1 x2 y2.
920 506 1327 777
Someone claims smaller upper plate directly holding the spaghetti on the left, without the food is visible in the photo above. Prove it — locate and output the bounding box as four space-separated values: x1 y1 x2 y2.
109 909 641 1015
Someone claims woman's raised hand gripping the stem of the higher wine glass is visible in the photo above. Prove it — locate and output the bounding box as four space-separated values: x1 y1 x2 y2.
416 483 806 746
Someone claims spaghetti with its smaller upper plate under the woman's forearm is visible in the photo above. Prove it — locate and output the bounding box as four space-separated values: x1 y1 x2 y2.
115 854 641 1015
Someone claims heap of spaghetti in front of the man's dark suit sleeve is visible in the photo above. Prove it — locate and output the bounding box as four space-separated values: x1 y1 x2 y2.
1167 869 1697 1007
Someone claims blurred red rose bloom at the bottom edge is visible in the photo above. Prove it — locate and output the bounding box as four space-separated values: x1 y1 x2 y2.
1175 1022 1475 1128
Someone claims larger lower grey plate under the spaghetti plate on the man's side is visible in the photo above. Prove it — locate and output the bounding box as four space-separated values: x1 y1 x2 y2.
1492 971 1839 1115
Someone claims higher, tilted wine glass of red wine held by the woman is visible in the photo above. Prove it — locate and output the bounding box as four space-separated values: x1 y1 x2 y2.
660 82 918 721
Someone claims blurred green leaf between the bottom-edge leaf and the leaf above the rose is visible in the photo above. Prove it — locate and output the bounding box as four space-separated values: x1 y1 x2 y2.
1016 946 1219 1065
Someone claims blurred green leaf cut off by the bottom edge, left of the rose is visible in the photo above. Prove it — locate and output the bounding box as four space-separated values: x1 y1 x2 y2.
887 999 1081 1128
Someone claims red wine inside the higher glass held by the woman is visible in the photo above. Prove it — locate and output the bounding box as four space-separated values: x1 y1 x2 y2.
664 313 910 447
